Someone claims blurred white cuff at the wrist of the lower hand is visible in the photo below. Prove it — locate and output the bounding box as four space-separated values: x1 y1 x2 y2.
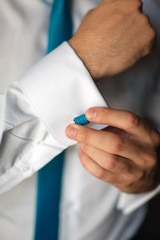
117 185 160 214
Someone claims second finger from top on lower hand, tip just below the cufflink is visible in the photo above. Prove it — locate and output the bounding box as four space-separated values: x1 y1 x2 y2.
66 124 146 166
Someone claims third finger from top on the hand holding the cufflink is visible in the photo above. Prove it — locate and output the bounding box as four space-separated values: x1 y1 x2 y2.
78 143 138 176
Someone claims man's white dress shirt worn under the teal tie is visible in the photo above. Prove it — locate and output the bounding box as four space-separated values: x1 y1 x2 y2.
0 0 160 240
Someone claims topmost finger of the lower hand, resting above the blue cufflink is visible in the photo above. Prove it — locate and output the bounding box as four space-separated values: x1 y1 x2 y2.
86 107 151 139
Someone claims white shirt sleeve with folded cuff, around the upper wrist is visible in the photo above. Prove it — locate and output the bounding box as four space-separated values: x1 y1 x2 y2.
0 42 107 194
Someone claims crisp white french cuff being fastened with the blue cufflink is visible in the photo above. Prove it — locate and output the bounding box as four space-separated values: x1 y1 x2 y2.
19 42 107 148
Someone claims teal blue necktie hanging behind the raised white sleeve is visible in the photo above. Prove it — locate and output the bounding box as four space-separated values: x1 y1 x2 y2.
34 0 72 240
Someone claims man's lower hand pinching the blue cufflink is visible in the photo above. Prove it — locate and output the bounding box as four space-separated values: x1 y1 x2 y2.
66 108 160 193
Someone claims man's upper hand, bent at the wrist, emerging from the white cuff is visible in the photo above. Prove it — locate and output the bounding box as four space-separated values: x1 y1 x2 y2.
69 0 155 80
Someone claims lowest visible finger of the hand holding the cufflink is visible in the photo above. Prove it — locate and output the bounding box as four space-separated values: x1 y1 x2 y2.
79 149 120 185
